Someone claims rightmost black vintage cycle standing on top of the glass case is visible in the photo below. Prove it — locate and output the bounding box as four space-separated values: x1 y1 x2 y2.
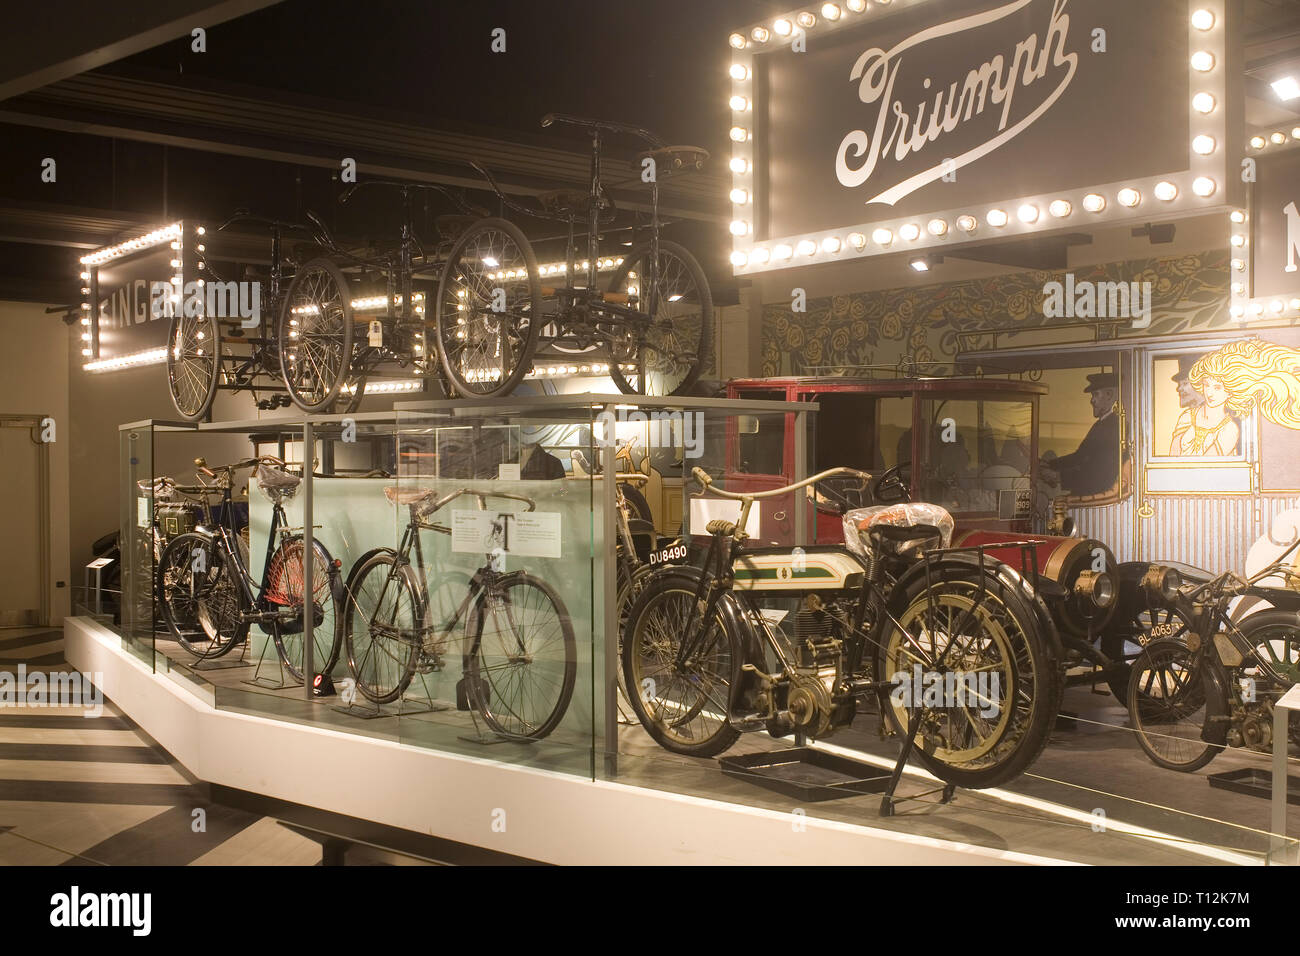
434 113 714 397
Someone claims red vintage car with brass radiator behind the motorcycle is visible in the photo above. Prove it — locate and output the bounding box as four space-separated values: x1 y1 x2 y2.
723 375 1199 701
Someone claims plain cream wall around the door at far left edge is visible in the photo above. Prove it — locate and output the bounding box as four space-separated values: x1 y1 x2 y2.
0 302 70 624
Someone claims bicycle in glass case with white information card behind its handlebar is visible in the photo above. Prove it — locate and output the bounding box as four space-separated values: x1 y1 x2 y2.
343 486 577 739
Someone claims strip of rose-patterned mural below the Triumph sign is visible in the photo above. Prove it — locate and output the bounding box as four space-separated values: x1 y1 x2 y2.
762 251 1230 376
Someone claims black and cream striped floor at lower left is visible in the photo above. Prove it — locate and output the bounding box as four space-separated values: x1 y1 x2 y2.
0 628 321 866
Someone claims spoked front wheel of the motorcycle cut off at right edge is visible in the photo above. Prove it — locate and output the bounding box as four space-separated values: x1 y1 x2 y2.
1128 637 1229 773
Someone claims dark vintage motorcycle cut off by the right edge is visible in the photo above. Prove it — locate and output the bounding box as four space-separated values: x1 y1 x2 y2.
1128 542 1300 773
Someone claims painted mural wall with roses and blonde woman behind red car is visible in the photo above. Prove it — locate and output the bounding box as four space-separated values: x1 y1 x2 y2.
762 251 1300 571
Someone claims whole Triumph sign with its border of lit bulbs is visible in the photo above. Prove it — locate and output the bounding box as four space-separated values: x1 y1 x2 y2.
729 0 1240 274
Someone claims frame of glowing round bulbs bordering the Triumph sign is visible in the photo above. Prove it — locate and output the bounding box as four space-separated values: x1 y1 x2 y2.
728 0 1232 276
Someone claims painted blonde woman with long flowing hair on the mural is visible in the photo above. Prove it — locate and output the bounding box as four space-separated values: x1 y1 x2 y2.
1169 338 1300 458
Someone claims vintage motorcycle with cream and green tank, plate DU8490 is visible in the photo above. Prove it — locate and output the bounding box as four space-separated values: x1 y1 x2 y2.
623 468 1063 803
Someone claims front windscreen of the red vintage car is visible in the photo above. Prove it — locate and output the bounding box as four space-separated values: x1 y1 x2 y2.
917 399 1034 519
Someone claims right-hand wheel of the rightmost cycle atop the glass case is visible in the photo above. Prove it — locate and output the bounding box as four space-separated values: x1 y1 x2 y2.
610 239 715 395
